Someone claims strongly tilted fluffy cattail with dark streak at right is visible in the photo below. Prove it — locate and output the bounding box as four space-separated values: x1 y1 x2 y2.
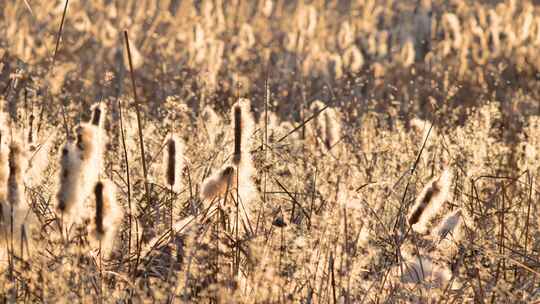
409 169 452 232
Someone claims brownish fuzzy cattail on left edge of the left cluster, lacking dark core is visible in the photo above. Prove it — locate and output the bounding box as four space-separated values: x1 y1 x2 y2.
56 143 82 214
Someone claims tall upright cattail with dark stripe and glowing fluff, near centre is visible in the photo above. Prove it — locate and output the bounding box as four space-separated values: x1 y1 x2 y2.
232 99 255 165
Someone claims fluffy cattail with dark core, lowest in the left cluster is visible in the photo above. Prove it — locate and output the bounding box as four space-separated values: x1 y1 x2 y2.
94 180 123 254
